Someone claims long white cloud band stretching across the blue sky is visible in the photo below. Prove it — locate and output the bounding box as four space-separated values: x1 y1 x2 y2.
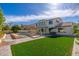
5 4 79 22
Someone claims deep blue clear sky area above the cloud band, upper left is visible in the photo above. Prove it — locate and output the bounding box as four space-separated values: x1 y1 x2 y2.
1 3 47 16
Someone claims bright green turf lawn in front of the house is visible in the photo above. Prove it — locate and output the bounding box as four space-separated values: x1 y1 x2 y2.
11 37 74 56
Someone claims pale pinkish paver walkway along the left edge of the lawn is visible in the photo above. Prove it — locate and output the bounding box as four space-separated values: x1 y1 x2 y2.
0 35 44 56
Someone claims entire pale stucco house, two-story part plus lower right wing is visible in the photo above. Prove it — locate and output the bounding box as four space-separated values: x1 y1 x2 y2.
36 17 73 34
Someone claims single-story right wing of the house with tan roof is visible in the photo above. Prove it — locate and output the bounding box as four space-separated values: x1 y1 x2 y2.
58 22 73 34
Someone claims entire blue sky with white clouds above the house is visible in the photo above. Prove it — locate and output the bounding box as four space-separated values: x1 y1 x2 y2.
0 3 79 22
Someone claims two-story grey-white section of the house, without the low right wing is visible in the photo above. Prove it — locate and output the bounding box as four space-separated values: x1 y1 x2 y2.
36 17 62 34
